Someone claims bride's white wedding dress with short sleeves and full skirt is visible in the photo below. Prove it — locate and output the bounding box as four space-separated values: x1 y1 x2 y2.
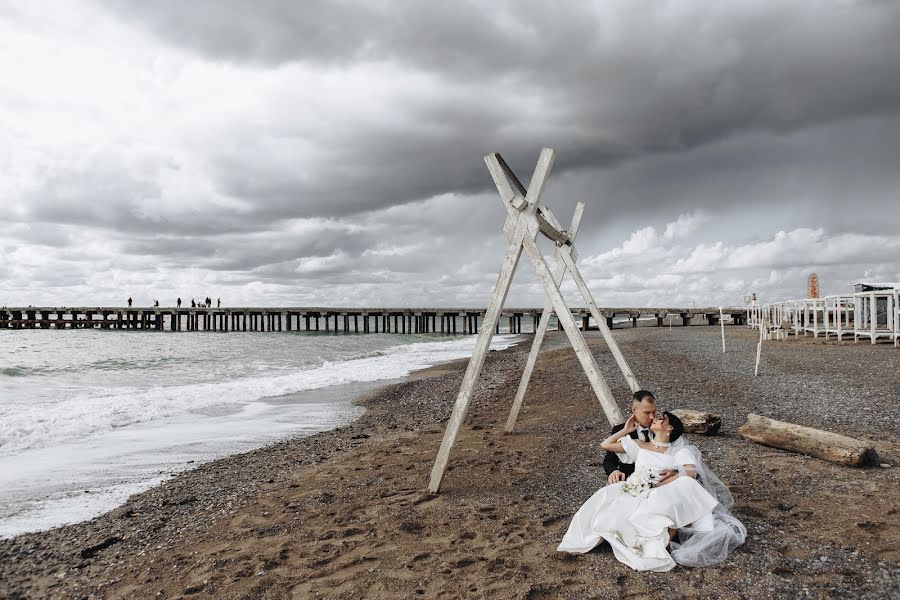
557 436 724 571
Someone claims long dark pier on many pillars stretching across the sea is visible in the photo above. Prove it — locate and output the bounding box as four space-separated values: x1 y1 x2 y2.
0 306 747 334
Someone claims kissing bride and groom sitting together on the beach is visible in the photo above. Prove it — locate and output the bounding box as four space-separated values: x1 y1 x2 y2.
557 390 747 571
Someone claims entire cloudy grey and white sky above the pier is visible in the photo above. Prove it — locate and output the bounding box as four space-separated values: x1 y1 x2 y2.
0 0 900 306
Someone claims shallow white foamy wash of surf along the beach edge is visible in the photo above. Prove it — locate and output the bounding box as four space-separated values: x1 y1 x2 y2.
0 336 521 539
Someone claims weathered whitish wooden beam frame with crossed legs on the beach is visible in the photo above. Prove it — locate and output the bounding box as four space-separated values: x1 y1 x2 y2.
428 148 640 494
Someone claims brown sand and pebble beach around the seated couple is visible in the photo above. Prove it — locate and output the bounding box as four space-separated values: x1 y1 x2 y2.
0 326 900 599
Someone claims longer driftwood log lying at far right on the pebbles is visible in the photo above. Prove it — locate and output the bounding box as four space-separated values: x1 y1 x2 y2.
738 414 878 467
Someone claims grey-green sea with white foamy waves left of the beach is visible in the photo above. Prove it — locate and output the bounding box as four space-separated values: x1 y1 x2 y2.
0 330 523 538
